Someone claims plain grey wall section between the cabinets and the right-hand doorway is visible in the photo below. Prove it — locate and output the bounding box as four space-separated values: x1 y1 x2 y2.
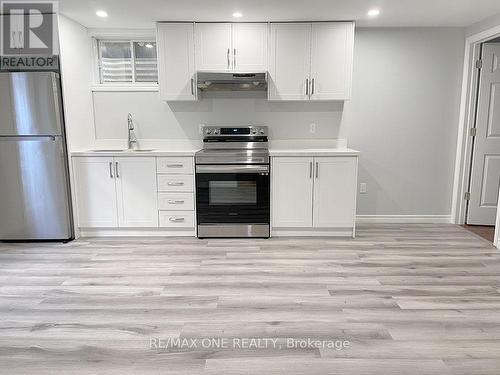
342 28 464 215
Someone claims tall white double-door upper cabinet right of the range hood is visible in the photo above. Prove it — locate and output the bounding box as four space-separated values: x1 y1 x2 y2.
268 22 354 100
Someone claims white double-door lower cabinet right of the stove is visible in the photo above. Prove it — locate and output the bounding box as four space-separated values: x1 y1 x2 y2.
271 156 358 235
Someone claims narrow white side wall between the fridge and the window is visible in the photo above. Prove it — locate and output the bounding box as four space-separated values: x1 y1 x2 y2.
59 15 93 151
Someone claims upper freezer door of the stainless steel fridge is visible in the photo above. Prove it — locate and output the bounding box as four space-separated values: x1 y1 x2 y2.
0 72 63 137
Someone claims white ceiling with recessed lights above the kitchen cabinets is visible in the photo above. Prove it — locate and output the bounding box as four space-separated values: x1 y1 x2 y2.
59 0 500 28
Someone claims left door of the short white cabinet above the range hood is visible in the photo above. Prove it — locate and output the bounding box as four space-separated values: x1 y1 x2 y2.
195 23 232 71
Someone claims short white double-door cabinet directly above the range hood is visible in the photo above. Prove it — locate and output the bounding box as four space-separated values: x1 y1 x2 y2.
195 23 268 72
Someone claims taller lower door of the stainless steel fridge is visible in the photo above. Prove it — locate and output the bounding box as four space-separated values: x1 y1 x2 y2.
0 137 73 240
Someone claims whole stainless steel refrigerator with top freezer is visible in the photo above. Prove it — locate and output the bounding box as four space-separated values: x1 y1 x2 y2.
0 72 74 241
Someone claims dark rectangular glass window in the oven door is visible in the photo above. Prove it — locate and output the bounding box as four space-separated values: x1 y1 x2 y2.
208 180 257 206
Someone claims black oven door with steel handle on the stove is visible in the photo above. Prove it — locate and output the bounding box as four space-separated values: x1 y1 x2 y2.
196 165 270 225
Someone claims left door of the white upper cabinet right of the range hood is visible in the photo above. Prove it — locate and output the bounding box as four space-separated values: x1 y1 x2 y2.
268 23 311 100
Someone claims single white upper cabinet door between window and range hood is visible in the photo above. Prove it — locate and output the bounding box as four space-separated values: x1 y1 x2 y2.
156 23 197 100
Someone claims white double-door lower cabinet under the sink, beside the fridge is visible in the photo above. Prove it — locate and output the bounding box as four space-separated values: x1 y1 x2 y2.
73 156 158 228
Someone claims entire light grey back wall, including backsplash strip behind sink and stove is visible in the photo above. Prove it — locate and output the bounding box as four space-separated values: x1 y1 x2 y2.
88 28 464 215
